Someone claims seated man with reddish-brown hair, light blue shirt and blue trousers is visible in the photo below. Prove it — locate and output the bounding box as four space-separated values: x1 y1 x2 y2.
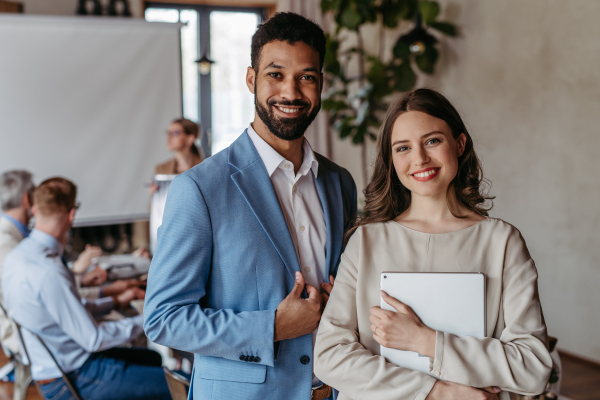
2 178 171 400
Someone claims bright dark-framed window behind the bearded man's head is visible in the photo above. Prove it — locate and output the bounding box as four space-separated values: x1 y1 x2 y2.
145 3 265 157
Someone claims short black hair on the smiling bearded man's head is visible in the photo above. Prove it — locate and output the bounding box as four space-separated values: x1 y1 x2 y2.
251 12 326 71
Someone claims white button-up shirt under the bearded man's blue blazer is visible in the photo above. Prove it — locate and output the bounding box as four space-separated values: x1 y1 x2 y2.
248 125 329 384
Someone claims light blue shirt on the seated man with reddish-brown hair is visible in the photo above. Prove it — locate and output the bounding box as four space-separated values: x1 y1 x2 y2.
2 229 144 380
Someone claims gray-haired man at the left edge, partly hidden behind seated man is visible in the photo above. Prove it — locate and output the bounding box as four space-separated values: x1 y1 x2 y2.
0 170 35 354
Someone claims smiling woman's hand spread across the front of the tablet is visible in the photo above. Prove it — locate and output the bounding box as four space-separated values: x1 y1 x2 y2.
369 290 435 358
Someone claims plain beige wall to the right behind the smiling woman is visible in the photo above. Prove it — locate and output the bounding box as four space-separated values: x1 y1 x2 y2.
326 0 600 361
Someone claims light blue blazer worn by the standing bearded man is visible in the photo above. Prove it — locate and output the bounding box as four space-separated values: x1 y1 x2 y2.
144 132 356 400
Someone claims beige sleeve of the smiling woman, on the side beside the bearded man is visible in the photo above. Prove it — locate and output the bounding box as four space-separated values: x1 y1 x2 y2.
314 238 437 400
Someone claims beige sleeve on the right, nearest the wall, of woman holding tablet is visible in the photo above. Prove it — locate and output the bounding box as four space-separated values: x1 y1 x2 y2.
431 229 552 395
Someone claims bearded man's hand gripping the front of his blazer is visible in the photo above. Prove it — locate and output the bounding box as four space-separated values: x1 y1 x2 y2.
273 272 321 342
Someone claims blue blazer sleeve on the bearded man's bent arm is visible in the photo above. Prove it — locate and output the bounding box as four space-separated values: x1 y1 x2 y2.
144 174 275 366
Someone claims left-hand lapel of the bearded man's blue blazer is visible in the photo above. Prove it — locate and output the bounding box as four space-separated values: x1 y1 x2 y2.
229 132 300 279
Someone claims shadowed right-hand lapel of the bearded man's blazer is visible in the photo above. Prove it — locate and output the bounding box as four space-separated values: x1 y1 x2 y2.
316 160 344 276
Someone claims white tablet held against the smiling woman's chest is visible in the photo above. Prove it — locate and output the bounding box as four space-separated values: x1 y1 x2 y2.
380 272 485 375
